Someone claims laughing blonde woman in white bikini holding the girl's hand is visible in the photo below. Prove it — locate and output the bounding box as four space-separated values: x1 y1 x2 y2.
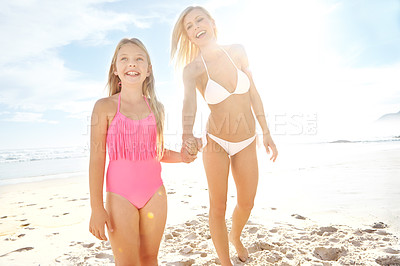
171 6 278 265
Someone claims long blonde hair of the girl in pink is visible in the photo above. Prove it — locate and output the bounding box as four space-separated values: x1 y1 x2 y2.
107 38 165 160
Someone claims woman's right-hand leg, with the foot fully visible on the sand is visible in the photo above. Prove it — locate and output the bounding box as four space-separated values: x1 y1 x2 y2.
229 141 258 261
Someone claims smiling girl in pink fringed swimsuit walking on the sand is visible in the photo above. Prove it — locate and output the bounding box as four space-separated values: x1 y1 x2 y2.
89 38 196 265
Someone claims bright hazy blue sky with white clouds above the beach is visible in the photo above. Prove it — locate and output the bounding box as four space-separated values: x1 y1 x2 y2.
0 0 400 149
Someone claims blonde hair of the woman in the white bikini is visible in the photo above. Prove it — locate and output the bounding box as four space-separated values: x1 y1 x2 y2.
171 6 217 68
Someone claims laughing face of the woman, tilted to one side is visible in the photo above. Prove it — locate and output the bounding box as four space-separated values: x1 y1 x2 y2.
183 9 215 46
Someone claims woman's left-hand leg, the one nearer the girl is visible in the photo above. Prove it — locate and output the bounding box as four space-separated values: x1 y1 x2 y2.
203 136 232 266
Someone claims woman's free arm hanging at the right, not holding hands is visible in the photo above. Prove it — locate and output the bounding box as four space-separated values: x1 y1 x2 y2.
235 45 278 162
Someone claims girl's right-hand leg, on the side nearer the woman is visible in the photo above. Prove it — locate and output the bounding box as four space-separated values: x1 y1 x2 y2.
139 186 167 266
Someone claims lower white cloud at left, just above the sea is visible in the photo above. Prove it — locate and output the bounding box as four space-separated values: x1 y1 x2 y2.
0 52 106 113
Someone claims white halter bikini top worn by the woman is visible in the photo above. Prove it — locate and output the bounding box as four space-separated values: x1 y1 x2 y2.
200 47 250 104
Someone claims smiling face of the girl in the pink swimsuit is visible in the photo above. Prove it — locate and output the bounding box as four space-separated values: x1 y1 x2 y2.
114 43 151 86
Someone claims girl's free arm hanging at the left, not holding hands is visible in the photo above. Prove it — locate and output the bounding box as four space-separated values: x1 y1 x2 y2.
89 99 112 240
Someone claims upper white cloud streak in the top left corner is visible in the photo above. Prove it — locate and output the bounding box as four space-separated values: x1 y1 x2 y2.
0 0 161 64
